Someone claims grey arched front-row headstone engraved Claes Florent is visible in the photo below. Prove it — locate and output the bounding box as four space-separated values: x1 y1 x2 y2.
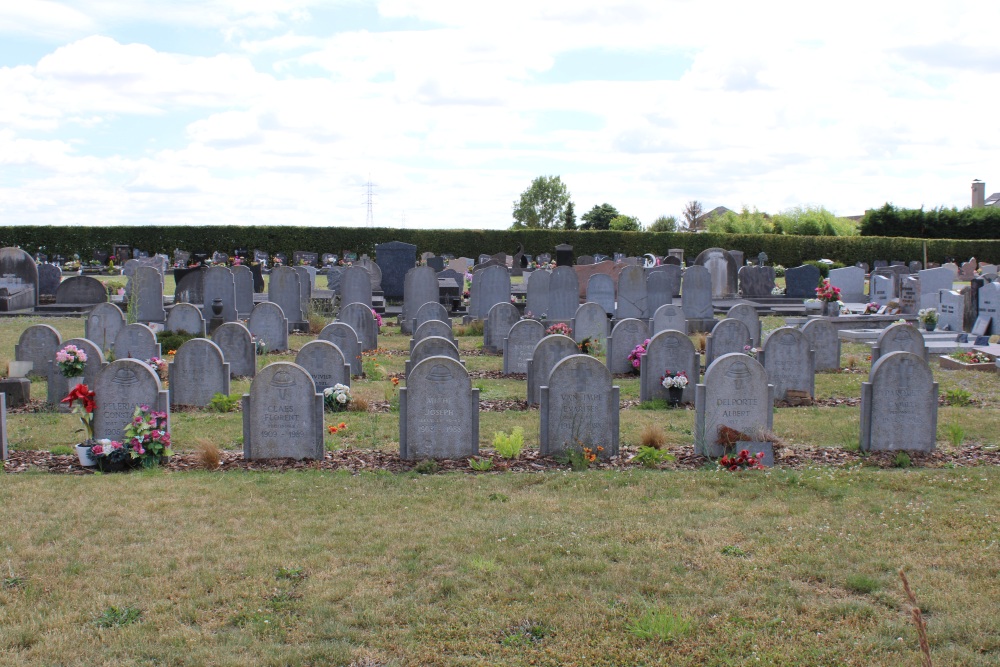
243 362 324 461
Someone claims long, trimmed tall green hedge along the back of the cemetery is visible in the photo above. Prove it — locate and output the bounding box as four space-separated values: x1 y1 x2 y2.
0 226 1000 266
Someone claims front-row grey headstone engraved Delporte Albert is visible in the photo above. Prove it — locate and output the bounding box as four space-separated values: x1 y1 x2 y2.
695 353 774 457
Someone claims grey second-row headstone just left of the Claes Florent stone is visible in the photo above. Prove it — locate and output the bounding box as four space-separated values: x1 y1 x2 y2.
168 338 230 408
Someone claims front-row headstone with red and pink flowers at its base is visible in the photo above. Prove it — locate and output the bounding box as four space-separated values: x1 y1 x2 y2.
93 360 170 442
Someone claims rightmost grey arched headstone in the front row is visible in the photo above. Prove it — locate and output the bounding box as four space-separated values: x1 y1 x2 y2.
861 352 938 452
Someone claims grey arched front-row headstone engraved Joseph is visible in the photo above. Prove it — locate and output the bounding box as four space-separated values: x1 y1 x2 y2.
399 357 479 460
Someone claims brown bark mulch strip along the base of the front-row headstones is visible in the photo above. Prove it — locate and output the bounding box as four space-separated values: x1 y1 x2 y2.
4 445 1000 475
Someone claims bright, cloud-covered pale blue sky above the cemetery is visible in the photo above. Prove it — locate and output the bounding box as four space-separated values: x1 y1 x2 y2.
0 0 1000 229
